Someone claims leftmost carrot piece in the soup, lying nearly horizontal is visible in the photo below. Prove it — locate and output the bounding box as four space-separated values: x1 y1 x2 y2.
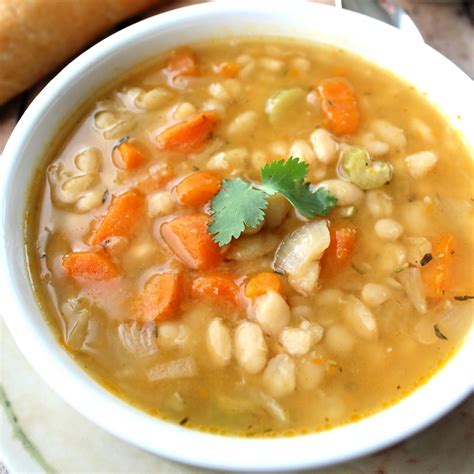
61 252 118 280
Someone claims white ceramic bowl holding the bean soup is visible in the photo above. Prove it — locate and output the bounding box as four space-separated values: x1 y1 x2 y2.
0 1 474 471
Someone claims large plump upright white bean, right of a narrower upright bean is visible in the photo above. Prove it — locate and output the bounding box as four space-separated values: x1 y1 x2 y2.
234 321 268 374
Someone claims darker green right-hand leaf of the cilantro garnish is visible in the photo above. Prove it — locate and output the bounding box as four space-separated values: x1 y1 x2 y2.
261 157 336 218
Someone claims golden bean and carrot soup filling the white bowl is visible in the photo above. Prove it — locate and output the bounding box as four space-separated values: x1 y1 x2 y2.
28 39 474 436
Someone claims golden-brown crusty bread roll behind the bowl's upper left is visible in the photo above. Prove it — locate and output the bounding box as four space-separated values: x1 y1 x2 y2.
0 0 165 105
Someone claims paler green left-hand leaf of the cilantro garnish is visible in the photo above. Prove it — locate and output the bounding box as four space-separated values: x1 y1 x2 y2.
208 178 268 247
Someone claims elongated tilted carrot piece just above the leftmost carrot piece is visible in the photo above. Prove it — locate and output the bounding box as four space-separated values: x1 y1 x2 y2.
92 191 145 245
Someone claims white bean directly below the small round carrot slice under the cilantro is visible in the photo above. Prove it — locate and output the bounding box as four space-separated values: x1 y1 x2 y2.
248 291 291 337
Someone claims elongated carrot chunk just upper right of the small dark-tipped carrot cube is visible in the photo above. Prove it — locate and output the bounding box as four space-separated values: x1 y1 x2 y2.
156 112 219 153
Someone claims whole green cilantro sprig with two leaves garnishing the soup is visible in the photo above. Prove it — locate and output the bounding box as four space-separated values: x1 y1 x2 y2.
208 157 336 247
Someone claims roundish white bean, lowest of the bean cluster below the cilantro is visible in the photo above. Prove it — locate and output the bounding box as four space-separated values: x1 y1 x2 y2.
262 354 296 398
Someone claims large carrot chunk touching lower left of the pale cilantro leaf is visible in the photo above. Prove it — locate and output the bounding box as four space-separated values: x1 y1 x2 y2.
160 214 222 270
